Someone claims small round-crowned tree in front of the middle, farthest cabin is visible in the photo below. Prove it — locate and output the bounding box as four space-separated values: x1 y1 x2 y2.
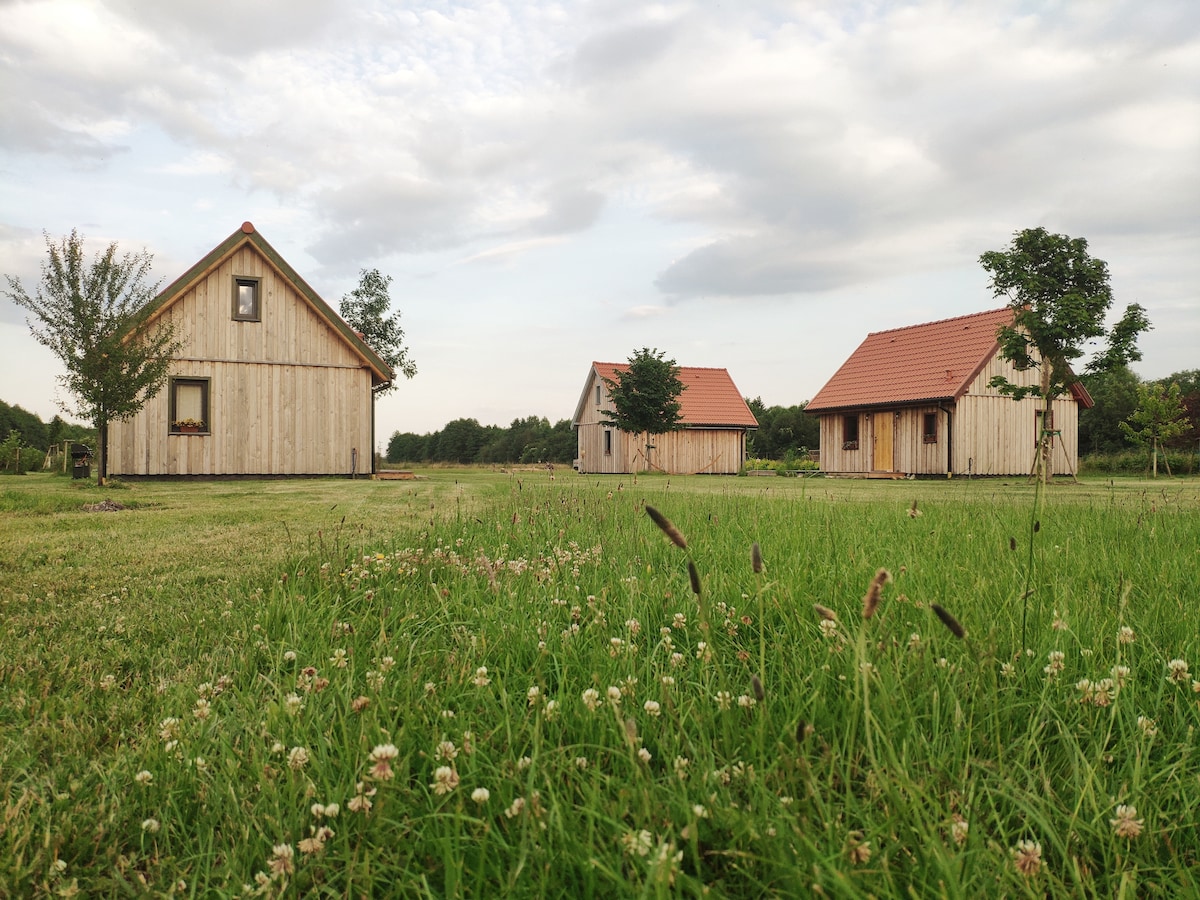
601 347 684 466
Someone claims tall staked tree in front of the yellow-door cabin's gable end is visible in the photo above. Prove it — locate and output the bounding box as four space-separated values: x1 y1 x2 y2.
979 228 1148 481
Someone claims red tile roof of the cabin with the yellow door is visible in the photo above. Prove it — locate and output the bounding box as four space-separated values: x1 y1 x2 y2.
806 306 1013 412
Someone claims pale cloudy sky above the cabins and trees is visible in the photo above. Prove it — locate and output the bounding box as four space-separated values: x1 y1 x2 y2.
0 0 1200 443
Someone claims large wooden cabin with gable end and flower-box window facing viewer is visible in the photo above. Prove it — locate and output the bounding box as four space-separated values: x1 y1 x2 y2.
108 222 392 476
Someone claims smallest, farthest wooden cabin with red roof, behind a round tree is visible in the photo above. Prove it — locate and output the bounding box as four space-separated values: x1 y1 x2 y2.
572 362 758 475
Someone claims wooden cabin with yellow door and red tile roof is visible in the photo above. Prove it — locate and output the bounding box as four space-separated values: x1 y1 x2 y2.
805 306 1092 476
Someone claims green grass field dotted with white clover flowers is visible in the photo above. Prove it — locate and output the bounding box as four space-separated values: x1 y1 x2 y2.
0 470 1200 898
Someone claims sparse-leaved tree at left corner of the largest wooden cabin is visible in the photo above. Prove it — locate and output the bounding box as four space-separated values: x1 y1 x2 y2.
4 230 180 484
